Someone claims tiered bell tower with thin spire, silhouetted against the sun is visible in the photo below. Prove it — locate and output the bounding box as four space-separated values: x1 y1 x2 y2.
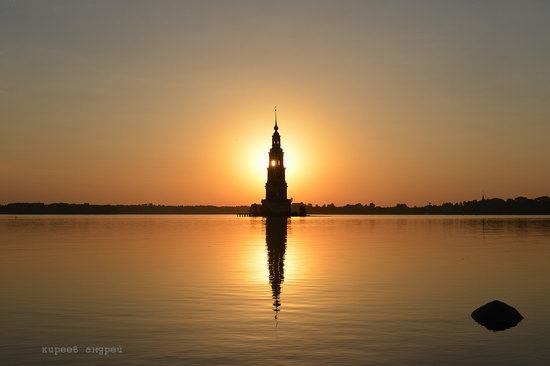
262 107 292 216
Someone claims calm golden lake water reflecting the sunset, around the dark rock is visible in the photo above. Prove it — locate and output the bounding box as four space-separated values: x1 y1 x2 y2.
0 216 550 365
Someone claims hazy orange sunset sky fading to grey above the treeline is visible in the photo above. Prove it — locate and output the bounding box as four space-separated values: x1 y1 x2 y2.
0 0 550 205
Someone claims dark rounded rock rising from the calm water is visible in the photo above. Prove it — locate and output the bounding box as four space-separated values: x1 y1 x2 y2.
472 300 523 332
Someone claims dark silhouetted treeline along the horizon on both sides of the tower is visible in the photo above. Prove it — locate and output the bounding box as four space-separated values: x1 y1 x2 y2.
0 196 550 215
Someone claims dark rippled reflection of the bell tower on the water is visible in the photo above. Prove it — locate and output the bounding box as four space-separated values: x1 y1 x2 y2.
265 217 289 319
